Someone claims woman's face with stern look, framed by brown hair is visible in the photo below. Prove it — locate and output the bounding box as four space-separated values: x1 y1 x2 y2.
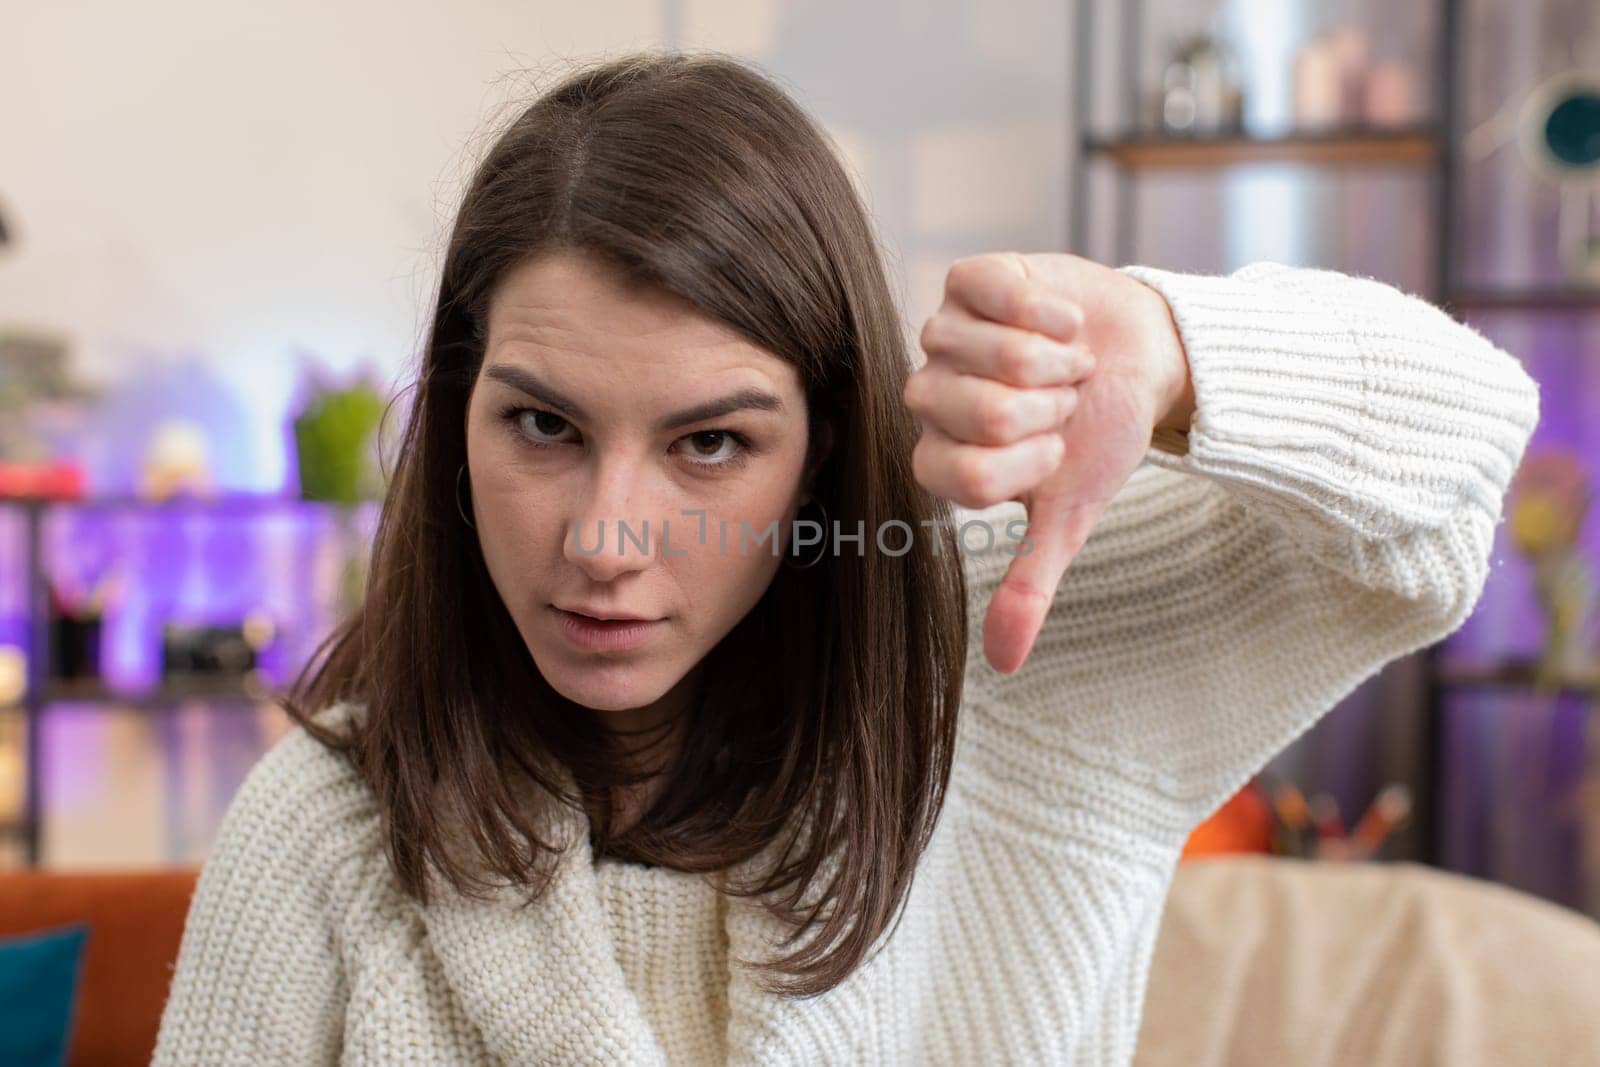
467 251 808 726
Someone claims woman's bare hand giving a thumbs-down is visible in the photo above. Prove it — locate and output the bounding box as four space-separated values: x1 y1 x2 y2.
904 253 1194 673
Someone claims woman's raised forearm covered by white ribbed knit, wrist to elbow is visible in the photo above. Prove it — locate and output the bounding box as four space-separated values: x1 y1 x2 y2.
1123 262 1539 559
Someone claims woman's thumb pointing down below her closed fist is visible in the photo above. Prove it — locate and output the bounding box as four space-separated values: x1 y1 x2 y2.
984 498 1106 673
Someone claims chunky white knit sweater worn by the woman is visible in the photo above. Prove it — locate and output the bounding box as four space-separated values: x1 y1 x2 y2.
155 262 1539 1067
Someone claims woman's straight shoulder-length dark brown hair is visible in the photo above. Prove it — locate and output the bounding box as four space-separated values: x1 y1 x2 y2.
286 53 968 997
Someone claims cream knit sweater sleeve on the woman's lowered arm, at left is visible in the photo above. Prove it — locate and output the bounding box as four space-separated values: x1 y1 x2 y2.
152 713 377 1067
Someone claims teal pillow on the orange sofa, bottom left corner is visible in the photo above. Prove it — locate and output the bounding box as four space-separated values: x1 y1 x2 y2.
0 923 90 1067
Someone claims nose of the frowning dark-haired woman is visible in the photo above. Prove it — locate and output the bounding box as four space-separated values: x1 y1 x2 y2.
562 453 668 582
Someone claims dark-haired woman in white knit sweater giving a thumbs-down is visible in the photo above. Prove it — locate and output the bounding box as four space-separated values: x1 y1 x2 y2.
155 56 1538 1064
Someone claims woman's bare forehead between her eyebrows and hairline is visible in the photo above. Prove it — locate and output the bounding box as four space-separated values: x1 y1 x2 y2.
488 250 798 390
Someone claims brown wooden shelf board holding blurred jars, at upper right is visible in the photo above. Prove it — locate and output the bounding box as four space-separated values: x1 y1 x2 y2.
1083 126 1438 170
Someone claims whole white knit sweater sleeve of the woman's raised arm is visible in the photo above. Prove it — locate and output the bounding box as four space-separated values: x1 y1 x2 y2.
963 262 1539 845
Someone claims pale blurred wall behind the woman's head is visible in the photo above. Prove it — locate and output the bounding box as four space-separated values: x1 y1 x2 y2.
0 0 1070 490
